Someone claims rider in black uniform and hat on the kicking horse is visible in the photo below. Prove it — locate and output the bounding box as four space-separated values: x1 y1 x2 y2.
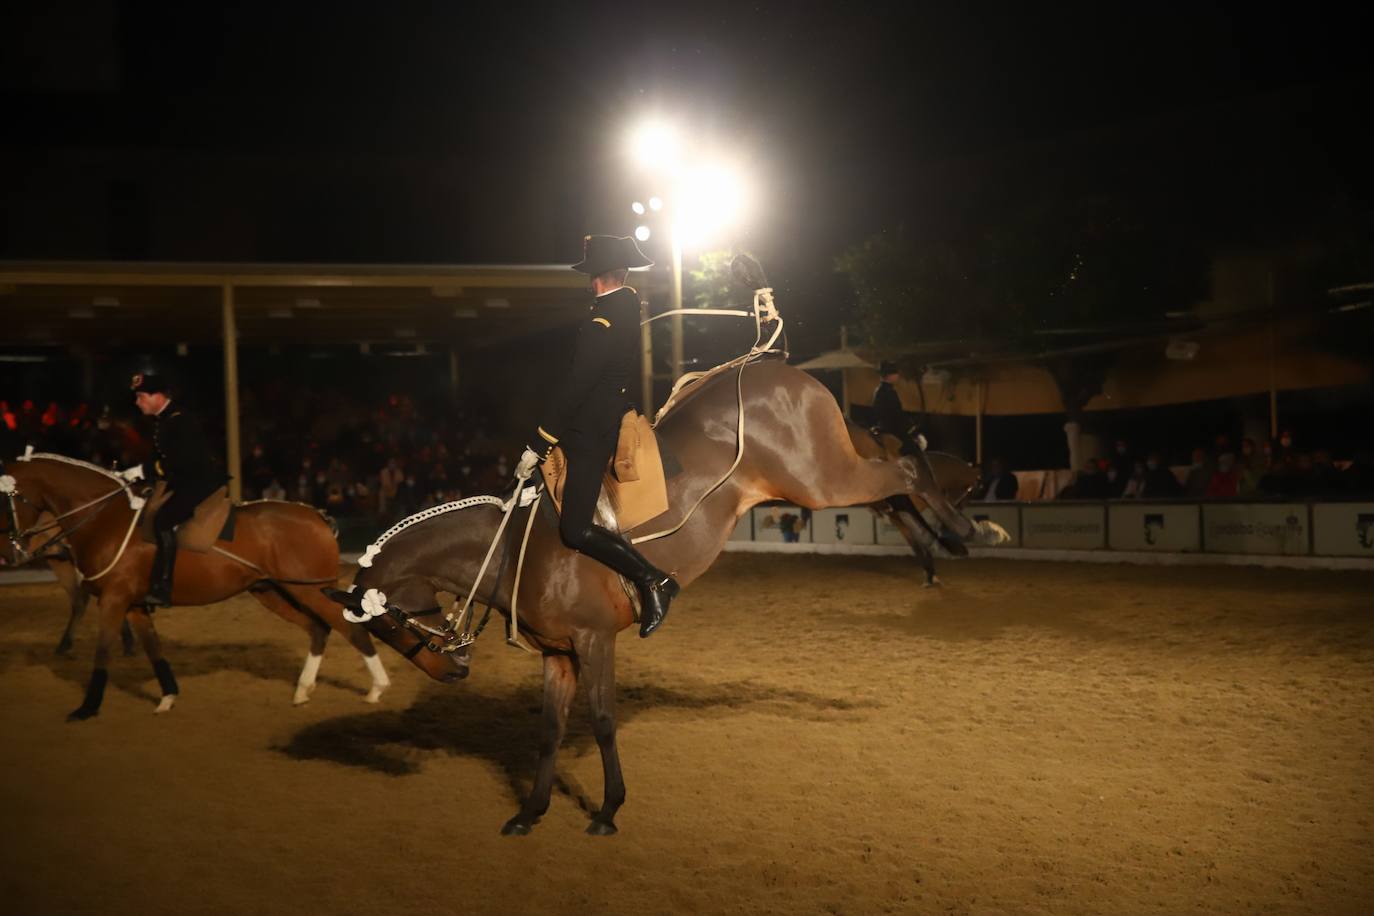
517 235 679 637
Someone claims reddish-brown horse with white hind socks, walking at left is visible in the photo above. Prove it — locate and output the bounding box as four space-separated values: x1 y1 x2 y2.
0 453 455 721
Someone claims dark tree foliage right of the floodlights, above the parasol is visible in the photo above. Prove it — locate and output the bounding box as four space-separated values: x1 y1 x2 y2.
838 199 1206 413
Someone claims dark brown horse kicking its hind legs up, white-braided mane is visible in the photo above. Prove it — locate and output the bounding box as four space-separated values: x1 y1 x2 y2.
331 360 1006 835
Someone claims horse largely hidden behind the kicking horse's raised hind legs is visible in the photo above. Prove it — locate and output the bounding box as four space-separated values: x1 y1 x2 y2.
846 420 980 588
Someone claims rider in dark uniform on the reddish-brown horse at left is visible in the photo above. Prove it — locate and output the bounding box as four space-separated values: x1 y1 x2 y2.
121 374 227 608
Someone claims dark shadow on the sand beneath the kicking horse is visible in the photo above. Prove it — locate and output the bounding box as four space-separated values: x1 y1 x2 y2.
275 672 878 814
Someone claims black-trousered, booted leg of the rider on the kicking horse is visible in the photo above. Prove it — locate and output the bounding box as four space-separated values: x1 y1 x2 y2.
558 439 679 636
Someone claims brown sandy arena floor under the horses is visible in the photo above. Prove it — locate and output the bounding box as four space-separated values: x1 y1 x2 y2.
0 555 1374 916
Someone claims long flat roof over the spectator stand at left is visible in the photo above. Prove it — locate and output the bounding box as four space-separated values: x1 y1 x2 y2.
0 261 599 350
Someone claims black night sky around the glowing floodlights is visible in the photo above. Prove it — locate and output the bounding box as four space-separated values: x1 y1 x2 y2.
0 0 1369 343
